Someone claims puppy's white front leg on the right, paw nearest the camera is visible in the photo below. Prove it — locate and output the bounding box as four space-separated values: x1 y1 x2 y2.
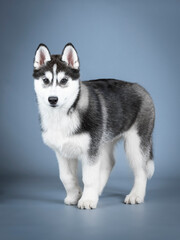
78 157 100 209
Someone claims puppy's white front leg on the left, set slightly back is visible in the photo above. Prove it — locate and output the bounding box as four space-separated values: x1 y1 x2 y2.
56 152 81 205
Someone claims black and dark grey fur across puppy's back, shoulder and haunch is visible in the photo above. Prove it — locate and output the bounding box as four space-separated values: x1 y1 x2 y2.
77 79 154 159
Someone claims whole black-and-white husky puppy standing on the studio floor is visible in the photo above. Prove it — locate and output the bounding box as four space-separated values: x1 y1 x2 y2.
33 43 155 209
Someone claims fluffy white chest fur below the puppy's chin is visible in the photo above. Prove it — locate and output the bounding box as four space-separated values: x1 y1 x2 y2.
40 106 90 158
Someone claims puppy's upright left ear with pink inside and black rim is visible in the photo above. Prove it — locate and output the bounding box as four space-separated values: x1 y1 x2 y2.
34 43 51 69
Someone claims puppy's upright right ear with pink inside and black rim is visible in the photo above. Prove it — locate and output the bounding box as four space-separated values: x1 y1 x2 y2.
62 43 79 69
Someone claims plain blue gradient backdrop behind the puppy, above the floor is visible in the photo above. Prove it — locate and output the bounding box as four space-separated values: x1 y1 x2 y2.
0 0 180 239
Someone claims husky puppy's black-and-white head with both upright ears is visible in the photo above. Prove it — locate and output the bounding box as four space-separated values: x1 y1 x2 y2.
33 44 80 108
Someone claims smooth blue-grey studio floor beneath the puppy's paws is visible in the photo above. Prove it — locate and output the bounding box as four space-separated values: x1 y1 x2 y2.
0 175 180 240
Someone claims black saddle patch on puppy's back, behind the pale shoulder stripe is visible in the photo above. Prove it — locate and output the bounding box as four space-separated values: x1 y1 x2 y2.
84 79 141 138
